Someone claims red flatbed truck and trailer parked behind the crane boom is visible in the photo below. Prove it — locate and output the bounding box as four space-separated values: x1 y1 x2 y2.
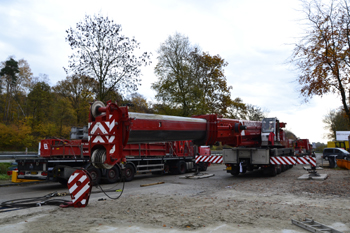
16 137 210 184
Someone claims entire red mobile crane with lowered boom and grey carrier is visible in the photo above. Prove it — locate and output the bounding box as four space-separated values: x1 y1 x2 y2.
88 101 314 176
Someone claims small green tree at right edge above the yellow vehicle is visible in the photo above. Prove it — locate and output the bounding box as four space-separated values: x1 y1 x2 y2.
323 108 350 140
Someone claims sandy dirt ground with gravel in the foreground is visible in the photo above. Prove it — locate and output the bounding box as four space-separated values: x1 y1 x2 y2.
0 162 350 233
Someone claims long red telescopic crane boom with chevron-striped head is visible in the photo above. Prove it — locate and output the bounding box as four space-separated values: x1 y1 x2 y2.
89 101 261 169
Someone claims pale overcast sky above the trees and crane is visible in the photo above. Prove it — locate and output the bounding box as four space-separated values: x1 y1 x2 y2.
0 0 341 142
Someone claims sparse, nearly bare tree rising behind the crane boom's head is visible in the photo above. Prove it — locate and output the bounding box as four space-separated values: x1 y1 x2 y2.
66 15 150 100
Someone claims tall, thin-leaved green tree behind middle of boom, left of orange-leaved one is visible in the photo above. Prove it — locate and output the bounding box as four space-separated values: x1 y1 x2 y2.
152 33 198 116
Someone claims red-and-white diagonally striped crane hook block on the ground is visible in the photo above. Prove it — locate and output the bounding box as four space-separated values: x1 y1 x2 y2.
61 169 92 208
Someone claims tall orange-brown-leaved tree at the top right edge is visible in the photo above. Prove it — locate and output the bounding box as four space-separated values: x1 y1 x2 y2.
290 0 350 124
